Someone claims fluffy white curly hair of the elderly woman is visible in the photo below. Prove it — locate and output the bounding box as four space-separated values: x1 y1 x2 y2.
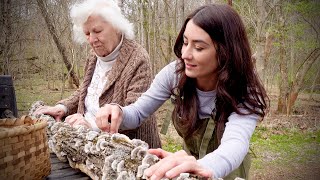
70 0 134 44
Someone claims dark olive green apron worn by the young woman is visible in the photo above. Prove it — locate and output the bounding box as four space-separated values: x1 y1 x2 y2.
173 94 251 180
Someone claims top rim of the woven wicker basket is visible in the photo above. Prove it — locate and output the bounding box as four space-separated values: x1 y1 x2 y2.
0 116 48 139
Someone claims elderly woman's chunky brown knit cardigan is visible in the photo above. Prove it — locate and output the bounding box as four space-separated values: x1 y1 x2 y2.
58 38 161 148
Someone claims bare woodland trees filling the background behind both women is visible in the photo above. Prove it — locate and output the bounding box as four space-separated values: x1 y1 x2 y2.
0 0 320 114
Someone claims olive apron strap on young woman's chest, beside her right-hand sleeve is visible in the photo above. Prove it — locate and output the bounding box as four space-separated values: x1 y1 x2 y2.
199 118 215 159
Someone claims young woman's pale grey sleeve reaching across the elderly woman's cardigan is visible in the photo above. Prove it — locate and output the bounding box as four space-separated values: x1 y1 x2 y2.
120 62 176 130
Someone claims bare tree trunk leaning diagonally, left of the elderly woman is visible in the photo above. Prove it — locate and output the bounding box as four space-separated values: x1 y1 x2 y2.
37 0 80 87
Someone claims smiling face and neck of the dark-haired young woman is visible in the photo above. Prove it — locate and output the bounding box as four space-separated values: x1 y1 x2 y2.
181 19 218 90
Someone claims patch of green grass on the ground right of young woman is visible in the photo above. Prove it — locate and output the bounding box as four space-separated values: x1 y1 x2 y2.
251 127 320 167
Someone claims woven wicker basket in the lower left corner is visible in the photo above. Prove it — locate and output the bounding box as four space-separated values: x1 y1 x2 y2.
0 116 51 179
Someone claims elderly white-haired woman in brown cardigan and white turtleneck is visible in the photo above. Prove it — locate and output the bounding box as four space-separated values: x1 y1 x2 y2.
36 0 161 148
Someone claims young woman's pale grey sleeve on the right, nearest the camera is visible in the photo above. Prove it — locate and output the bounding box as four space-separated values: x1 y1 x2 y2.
198 113 259 178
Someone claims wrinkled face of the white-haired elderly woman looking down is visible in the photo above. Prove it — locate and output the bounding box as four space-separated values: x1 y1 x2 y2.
83 15 121 57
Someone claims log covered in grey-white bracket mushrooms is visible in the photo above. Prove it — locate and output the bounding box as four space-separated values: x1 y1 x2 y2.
29 101 205 180
